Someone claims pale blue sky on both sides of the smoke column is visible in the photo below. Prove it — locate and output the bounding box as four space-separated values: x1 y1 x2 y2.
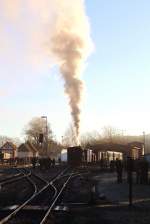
0 0 150 139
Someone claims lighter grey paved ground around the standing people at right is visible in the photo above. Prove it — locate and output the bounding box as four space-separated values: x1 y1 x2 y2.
93 173 150 207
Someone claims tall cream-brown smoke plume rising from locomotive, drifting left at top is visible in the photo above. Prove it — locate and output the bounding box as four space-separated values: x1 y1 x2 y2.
0 0 91 136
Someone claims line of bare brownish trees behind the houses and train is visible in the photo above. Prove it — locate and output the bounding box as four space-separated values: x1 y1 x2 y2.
24 117 143 157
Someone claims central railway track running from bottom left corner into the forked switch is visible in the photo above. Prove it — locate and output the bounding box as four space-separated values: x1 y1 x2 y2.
0 169 69 224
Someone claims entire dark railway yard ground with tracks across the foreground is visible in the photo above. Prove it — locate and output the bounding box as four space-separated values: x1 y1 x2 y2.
0 165 150 224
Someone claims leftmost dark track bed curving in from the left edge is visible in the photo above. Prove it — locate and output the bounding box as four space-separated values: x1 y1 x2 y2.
0 169 43 212
